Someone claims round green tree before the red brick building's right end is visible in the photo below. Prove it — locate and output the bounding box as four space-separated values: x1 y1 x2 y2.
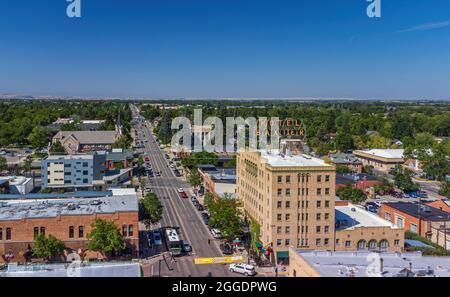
87 219 125 256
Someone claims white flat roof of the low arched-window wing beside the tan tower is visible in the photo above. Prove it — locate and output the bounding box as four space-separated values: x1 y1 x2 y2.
334 204 398 231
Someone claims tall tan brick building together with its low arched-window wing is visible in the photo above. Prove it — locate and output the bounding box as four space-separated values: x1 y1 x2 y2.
236 143 404 260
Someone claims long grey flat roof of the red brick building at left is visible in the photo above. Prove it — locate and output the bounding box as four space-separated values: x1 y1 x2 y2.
0 194 138 221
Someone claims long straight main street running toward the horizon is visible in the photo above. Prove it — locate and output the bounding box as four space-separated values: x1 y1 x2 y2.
131 105 237 277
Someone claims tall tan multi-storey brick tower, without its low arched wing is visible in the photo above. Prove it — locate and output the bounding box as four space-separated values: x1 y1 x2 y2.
236 145 335 260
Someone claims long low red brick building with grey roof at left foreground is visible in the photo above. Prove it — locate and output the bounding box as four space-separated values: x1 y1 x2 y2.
0 195 139 262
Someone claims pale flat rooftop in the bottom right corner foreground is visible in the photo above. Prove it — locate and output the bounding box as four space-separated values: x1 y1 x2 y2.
291 250 450 277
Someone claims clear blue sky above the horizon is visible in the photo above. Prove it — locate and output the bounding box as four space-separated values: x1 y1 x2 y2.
0 0 450 100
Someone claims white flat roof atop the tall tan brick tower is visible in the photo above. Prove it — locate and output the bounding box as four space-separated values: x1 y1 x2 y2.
260 150 333 168
